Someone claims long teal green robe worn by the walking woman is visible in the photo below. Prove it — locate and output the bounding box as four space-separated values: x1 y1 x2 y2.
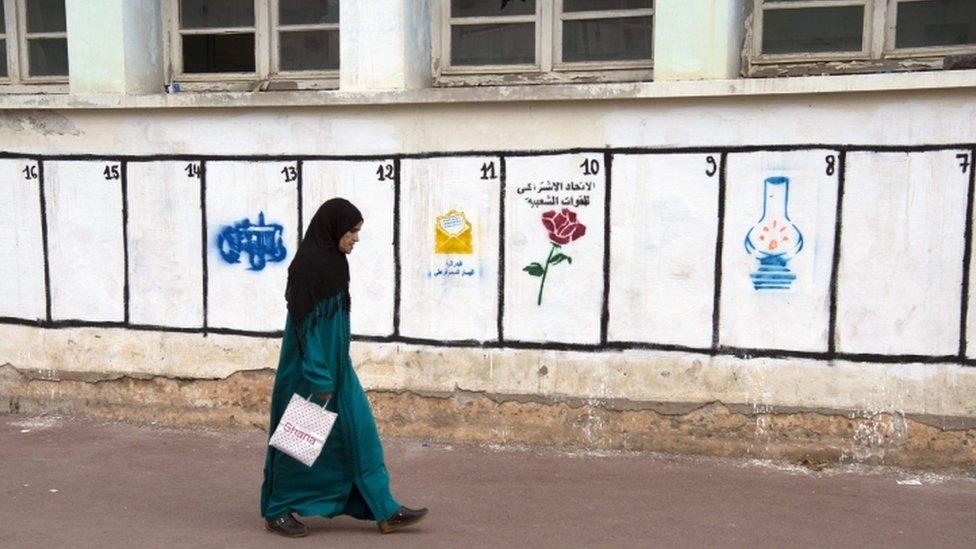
261 293 400 522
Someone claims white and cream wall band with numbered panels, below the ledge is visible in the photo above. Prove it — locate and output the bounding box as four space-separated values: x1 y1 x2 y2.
0 86 976 462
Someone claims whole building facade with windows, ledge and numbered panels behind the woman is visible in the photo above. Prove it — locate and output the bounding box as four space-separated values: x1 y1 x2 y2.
0 0 976 465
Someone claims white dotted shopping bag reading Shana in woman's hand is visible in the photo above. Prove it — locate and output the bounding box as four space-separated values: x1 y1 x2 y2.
268 393 339 467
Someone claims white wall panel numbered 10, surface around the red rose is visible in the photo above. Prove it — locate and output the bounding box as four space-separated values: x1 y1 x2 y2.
504 154 606 344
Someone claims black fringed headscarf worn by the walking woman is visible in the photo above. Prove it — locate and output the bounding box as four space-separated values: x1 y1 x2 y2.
285 198 363 333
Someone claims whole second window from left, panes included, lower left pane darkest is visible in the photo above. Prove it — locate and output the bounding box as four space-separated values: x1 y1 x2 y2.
167 0 339 90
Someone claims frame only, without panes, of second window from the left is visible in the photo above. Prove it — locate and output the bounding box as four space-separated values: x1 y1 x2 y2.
163 0 342 91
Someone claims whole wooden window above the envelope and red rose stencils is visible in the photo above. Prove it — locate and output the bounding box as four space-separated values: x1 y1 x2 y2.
433 0 654 85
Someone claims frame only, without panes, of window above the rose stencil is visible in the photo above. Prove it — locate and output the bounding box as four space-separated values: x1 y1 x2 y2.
431 0 657 87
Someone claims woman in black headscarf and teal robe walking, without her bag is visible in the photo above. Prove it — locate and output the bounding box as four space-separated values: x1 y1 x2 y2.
261 198 427 537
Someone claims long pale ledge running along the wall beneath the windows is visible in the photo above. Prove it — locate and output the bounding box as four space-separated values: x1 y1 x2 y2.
0 69 976 109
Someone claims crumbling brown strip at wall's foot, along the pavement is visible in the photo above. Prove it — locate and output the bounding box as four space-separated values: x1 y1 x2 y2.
0 365 976 467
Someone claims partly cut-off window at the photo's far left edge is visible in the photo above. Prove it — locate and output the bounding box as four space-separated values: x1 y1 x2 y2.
0 0 68 90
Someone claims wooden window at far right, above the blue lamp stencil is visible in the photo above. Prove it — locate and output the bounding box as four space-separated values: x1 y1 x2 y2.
747 0 976 76
